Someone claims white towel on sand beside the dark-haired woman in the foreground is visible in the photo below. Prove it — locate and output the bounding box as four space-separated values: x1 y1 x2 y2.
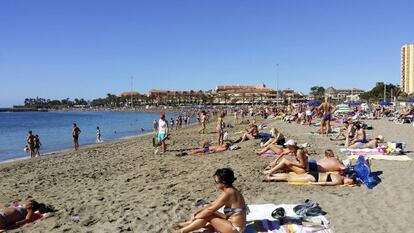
245 204 333 233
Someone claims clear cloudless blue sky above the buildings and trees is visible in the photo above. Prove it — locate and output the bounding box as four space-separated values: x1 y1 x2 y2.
0 0 414 107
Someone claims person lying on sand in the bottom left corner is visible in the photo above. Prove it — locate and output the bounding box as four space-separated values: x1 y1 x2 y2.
0 200 53 230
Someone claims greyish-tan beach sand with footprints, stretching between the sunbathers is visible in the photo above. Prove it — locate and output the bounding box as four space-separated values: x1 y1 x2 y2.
0 117 414 232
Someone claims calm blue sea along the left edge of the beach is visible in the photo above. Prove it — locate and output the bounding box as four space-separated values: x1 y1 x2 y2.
0 112 184 162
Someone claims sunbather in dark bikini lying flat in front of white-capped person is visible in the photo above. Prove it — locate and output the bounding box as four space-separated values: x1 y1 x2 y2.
263 172 355 186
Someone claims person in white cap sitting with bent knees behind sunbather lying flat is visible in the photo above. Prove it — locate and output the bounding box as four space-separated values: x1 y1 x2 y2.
263 139 309 175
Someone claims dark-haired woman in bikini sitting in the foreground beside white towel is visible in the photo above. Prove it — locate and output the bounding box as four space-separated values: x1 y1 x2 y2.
177 168 247 233
